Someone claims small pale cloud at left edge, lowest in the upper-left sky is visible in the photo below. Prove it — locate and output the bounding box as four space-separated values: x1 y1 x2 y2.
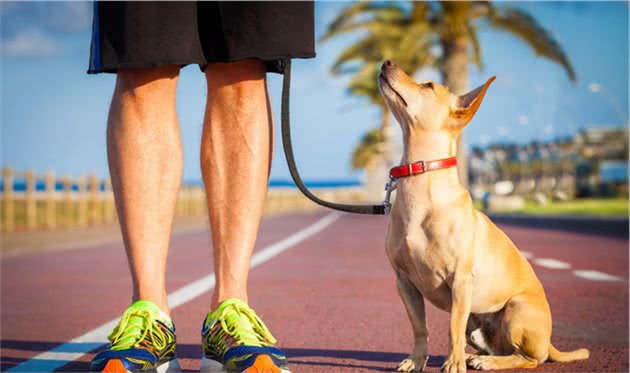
0 29 61 57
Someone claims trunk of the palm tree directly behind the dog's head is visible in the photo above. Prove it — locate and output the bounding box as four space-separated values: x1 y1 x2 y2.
440 37 469 187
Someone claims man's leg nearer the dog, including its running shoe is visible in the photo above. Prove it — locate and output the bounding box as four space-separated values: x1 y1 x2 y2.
200 60 289 373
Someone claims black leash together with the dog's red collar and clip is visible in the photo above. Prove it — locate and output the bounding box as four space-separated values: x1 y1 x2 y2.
281 59 457 215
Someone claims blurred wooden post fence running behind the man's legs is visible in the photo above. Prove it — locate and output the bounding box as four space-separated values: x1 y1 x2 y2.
0 167 366 232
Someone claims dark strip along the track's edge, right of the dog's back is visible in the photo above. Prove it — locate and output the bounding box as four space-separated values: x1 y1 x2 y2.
488 213 628 240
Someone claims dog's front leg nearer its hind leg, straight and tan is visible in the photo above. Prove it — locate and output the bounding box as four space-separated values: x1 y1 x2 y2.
442 270 473 373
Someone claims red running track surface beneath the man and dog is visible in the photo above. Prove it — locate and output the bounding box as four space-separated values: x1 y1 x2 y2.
0 212 628 372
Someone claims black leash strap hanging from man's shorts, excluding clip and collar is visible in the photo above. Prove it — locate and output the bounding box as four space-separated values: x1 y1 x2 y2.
281 59 389 215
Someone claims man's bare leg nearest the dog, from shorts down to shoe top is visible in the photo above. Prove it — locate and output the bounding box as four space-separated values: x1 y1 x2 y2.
201 60 273 309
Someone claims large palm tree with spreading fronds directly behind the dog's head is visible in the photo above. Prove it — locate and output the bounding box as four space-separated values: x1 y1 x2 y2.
322 1 575 183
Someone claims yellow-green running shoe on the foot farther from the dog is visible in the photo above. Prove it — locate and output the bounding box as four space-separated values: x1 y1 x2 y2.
90 300 180 373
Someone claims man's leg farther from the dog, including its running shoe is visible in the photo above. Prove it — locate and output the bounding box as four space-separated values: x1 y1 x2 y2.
90 66 182 373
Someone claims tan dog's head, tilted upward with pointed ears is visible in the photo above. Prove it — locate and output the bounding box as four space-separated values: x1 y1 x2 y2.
378 61 495 135
